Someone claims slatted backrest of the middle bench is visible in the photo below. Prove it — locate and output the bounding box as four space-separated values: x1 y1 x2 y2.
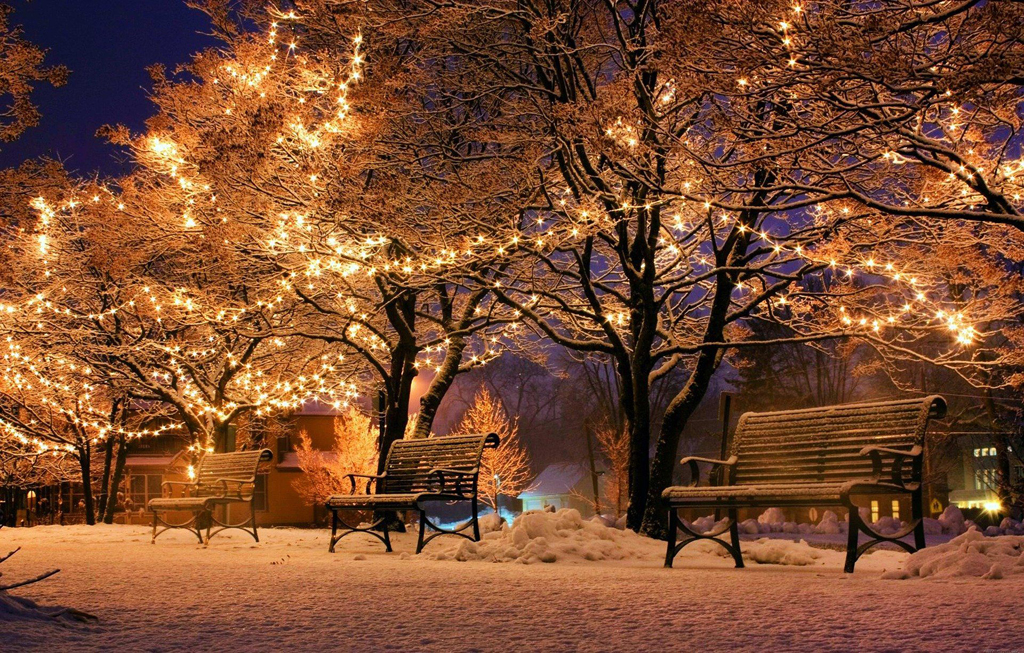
378 433 498 494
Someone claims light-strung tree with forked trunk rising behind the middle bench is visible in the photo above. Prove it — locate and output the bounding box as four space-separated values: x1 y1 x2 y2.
112 3 532 470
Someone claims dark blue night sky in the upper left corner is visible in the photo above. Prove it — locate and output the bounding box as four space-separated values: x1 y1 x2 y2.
0 0 215 174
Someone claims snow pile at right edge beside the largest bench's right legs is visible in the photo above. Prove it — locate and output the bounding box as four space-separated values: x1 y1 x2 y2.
883 528 1024 580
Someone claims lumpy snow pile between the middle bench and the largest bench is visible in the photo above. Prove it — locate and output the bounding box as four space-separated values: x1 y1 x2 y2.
423 509 665 564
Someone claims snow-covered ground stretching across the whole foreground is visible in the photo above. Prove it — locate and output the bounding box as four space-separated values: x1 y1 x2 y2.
0 511 1024 651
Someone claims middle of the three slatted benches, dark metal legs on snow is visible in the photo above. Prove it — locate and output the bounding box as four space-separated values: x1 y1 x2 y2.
327 433 499 553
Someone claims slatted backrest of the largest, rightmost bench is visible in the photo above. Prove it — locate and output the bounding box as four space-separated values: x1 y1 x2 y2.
730 395 946 485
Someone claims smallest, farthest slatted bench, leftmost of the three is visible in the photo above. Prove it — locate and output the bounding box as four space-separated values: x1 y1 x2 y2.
148 449 273 542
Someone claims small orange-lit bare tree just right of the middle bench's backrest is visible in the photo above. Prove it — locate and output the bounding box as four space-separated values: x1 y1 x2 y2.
453 388 534 512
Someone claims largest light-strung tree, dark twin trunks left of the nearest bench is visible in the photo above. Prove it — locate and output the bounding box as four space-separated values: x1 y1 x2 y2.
348 0 1020 534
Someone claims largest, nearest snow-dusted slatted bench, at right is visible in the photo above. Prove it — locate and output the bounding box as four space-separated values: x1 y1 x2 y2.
662 396 946 573
